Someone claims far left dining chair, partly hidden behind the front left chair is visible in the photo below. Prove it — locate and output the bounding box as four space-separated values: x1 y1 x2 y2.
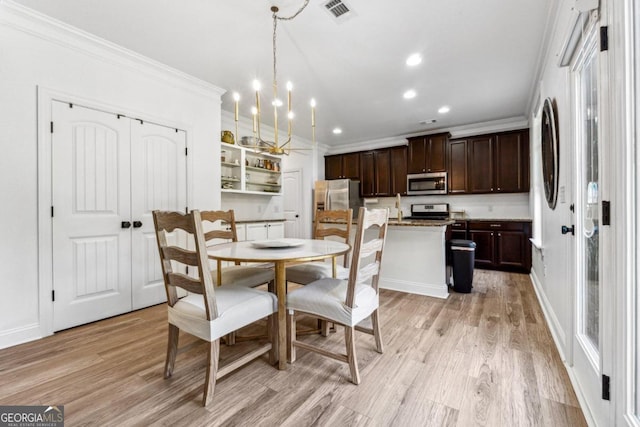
200 210 275 290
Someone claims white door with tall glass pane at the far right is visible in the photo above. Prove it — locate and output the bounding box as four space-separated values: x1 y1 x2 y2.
572 16 613 425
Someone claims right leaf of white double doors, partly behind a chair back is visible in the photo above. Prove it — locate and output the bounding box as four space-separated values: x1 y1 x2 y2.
131 120 187 310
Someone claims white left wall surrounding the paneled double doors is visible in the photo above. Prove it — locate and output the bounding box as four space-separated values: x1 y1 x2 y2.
0 3 222 348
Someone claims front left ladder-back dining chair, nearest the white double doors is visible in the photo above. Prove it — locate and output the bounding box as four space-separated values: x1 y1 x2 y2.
153 210 278 406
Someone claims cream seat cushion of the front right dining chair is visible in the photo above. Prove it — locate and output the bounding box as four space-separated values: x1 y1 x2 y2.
287 278 378 326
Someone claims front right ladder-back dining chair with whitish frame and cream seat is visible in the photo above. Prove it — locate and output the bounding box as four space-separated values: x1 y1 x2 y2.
287 208 389 384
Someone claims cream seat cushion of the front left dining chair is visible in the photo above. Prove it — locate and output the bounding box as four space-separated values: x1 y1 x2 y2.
169 286 278 341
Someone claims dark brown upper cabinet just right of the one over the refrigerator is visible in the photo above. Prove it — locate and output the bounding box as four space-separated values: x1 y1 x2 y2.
360 149 392 197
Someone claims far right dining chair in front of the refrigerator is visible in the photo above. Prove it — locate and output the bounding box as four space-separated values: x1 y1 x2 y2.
286 209 353 285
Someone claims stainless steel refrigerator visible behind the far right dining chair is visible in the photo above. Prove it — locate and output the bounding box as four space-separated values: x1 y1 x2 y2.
313 179 363 218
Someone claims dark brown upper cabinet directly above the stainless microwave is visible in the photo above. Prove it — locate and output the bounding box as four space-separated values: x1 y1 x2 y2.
407 133 449 173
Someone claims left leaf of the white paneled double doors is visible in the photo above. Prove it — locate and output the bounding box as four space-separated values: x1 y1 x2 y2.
52 101 131 331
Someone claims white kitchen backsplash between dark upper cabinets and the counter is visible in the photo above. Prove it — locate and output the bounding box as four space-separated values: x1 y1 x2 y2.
365 193 531 219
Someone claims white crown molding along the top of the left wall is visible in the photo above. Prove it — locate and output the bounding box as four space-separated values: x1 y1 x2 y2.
0 0 226 98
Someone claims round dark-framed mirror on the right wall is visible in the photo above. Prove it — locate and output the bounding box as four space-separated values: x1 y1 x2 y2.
541 98 558 209
